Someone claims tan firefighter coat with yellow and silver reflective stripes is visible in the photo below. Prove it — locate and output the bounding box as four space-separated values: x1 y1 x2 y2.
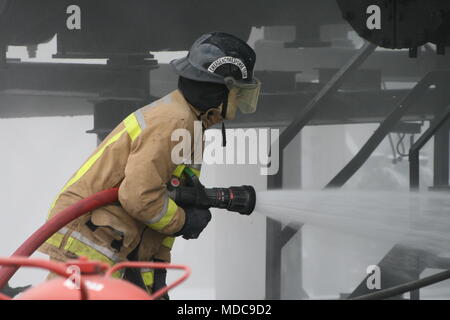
39 90 222 264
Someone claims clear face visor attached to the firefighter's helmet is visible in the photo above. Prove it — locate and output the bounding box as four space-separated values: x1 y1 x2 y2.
224 77 261 114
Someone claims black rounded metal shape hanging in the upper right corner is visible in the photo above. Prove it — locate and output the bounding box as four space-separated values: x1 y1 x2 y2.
337 0 450 56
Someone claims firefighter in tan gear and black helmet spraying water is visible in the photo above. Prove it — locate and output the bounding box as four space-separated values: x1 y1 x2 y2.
39 32 261 292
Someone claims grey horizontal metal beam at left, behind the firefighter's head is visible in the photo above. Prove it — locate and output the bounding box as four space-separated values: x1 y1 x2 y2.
0 61 157 99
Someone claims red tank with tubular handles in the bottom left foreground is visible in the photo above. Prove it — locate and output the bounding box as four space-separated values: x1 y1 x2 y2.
0 257 191 300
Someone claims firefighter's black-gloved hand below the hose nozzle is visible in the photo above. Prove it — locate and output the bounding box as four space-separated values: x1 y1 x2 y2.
174 207 211 240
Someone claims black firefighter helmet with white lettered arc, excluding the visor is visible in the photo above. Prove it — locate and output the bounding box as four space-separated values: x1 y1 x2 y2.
170 32 256 84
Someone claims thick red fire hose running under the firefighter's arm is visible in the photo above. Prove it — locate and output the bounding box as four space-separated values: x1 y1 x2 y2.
0 188 119 289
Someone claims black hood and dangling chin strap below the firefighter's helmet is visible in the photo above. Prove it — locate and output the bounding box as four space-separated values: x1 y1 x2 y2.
178 77 229 146
